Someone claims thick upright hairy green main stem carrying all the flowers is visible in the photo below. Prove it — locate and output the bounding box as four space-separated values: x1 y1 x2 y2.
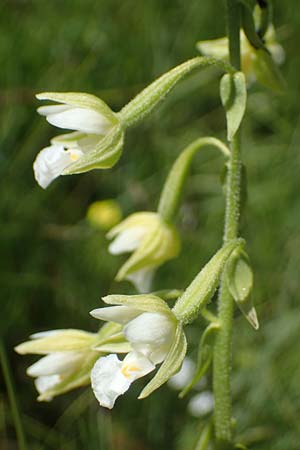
213 0 241 449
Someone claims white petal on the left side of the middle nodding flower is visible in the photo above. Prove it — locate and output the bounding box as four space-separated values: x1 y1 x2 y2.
108 226 148 255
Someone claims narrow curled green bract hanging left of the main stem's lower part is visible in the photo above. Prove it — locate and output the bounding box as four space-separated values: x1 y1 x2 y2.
179 322 220 398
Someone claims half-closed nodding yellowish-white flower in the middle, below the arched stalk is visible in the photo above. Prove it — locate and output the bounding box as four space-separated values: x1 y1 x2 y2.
107 212 180 292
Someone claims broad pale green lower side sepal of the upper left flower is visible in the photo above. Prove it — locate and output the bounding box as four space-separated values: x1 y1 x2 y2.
62 124 124 175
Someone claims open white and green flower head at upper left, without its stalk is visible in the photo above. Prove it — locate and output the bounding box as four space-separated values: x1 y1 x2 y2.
33 92 123 188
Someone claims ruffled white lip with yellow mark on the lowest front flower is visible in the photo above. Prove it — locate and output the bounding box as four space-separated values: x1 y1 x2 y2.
91 352 155 409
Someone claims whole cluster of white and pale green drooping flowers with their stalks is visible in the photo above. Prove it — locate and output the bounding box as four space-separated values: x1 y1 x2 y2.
16 24 279 408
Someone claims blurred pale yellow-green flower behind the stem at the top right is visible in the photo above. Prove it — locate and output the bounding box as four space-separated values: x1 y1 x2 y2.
196 26 284 88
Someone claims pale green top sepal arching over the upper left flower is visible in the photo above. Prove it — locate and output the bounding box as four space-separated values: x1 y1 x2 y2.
36 92 118 124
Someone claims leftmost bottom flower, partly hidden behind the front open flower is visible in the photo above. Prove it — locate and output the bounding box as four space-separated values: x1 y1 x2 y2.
15 324 129 401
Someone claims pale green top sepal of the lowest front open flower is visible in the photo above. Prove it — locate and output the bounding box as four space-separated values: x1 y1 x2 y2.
102 294 175 320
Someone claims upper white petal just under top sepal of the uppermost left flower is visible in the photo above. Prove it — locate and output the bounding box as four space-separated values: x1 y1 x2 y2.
47 107 111 135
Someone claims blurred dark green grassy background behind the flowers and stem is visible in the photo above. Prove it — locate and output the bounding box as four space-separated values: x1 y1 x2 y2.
0 0 300 450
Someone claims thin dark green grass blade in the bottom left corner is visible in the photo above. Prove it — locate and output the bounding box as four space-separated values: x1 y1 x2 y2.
0 340 27 450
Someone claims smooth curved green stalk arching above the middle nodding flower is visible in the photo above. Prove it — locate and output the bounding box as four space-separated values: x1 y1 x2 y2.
158 137 230 222
